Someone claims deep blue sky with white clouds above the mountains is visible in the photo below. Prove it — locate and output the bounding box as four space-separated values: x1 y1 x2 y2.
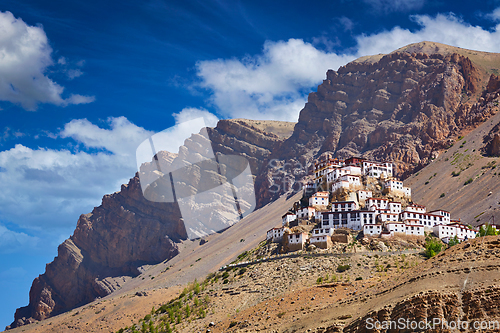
0 0 500 327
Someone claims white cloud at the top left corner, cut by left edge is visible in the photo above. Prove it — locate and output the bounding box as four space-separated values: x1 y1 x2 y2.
0 12 94 111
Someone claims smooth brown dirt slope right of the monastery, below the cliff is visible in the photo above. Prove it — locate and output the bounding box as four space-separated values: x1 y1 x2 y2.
404 102 500 225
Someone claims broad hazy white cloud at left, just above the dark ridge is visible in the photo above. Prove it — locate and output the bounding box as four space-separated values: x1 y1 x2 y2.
0 117 153 233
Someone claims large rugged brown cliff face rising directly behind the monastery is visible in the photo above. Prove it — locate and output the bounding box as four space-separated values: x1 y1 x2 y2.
257 52 498 204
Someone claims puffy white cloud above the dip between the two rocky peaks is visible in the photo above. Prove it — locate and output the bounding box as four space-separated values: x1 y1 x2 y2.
197 39 354 121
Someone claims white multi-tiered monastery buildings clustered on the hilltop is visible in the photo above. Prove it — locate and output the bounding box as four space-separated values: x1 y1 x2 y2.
267 157 478 251
